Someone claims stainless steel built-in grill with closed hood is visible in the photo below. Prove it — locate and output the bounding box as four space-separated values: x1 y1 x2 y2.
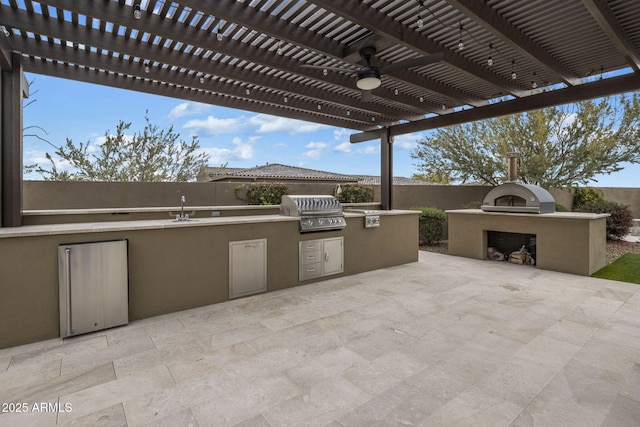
280 195 347 233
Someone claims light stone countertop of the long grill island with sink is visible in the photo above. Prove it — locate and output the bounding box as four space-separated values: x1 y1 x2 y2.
0 208 419 239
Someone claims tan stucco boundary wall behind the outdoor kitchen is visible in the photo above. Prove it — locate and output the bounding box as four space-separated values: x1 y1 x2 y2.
24 181 640 218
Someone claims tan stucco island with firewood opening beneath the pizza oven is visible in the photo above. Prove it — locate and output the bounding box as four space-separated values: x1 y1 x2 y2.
446 209 609 276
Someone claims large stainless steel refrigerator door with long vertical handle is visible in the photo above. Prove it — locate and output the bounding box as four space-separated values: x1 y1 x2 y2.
58 240 129 337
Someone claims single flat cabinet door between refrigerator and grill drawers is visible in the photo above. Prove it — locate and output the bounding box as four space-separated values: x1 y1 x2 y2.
229 239 267 298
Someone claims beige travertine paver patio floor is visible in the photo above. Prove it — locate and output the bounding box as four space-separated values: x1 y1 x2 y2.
0 252 640 427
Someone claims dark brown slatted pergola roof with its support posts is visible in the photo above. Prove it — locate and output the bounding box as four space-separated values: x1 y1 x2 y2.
0 0 640 226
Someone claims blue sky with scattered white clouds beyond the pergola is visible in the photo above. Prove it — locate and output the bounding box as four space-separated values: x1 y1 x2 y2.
24 74 640 187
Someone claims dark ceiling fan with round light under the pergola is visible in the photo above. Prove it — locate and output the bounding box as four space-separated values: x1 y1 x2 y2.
302 46 444 101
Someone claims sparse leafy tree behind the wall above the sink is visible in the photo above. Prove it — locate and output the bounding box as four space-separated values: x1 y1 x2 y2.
36 115 210 182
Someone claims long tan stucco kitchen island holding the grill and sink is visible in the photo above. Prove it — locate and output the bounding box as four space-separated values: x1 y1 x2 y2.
0 210 418 348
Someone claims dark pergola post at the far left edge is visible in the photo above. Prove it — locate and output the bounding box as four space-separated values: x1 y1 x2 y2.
0 52 28 227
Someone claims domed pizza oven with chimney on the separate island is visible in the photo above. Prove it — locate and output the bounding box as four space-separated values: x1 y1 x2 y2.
480 153 556 214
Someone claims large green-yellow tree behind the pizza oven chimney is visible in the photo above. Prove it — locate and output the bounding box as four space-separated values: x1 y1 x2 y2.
411 92 640 188
